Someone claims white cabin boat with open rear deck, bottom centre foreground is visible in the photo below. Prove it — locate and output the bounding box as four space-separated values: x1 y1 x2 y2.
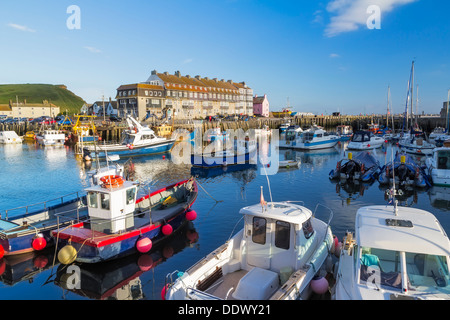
162 189 333 300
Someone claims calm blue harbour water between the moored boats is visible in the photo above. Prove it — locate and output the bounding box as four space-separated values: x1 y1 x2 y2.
0 143 450 300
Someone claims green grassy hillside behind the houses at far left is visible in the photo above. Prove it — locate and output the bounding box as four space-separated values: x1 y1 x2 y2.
0 84 85 114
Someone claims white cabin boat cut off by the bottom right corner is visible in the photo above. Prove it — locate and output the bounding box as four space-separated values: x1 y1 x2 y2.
334 201 450 300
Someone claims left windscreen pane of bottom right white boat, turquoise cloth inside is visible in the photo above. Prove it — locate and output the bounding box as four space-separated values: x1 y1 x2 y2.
360 248 402 291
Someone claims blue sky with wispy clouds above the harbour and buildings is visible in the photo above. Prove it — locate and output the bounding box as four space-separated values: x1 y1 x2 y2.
0 0 450 114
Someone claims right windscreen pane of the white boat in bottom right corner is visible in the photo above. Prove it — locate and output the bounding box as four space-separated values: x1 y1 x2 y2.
405 252 450 294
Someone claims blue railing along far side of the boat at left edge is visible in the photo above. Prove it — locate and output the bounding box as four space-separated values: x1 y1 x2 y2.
0 192 81 220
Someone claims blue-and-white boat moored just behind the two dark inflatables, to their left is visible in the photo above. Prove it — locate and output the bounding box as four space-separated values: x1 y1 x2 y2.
284 125 339 150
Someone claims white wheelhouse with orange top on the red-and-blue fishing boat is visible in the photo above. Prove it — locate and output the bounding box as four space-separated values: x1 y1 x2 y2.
86 176 137 234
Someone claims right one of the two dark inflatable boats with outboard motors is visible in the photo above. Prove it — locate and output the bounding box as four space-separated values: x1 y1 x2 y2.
378 153 430 188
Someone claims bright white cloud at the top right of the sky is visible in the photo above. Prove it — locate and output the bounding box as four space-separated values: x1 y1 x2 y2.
325 0 417 37
